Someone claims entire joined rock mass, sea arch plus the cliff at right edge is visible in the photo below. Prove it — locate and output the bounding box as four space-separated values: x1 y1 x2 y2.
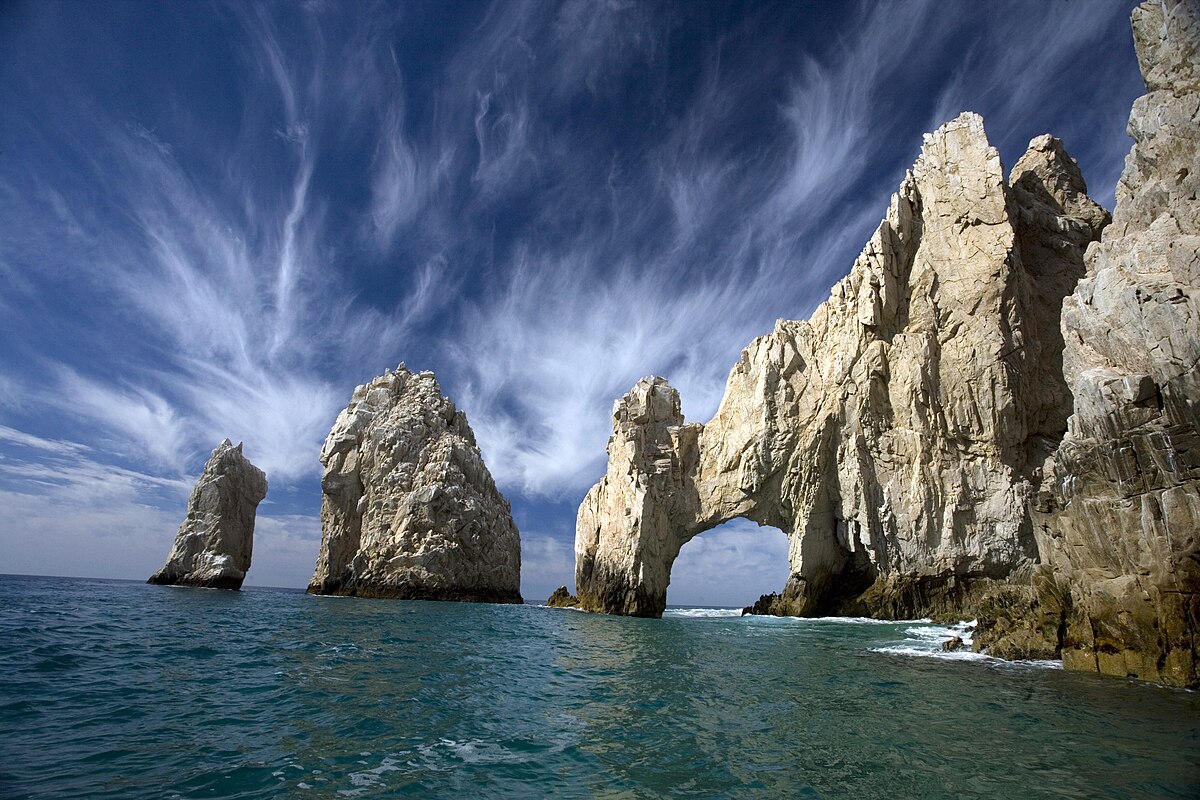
576 0 1200 685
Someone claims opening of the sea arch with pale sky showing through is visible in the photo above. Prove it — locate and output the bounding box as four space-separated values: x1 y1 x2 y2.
666 517 790 608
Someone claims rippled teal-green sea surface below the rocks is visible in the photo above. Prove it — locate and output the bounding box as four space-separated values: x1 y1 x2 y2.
0 576 1200 800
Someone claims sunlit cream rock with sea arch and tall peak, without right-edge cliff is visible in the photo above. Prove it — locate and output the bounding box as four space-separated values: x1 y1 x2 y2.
576 114 1108 616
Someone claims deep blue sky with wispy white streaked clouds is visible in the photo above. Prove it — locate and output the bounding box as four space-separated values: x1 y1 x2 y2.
0 0 1144 606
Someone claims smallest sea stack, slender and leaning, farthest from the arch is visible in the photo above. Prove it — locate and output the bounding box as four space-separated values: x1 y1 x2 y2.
146 439 266 589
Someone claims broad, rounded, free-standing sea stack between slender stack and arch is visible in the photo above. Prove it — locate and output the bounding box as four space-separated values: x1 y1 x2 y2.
308 365 522 603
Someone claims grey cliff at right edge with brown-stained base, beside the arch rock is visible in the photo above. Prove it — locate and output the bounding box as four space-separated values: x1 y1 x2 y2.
1017 1 1200 686
